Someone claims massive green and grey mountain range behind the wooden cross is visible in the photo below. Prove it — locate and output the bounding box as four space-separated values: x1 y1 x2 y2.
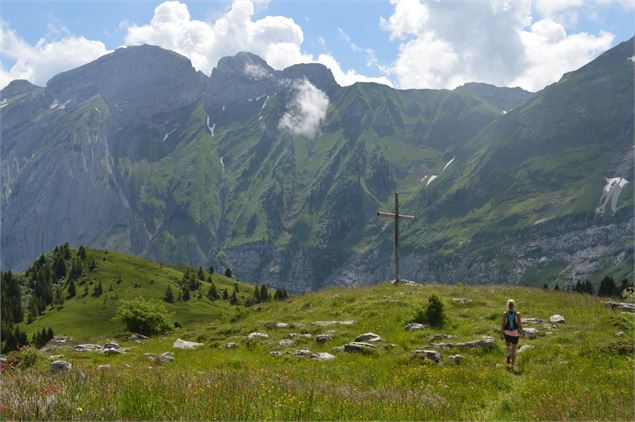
0 39 635 291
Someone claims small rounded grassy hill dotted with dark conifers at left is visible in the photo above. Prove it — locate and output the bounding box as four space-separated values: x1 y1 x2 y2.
22 249 254 340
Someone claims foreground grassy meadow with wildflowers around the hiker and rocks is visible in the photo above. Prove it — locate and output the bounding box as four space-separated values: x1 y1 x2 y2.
2 270 635 420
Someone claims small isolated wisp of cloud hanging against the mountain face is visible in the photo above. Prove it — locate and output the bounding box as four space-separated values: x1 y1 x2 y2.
278 79 329 138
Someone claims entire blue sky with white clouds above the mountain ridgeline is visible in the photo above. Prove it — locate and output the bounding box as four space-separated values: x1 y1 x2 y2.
0 0 635 91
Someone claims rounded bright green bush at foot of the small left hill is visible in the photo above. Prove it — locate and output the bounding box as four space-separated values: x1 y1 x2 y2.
114 298 172 335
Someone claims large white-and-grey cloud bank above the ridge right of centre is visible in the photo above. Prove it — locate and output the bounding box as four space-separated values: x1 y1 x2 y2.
379 0 612 91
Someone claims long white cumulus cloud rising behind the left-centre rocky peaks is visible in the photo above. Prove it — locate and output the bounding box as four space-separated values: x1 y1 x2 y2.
123 0 388 85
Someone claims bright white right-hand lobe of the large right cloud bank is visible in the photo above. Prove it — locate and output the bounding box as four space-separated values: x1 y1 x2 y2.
510 19 614 91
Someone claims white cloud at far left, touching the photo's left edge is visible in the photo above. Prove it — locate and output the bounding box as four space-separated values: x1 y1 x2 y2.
0 22 109 88
